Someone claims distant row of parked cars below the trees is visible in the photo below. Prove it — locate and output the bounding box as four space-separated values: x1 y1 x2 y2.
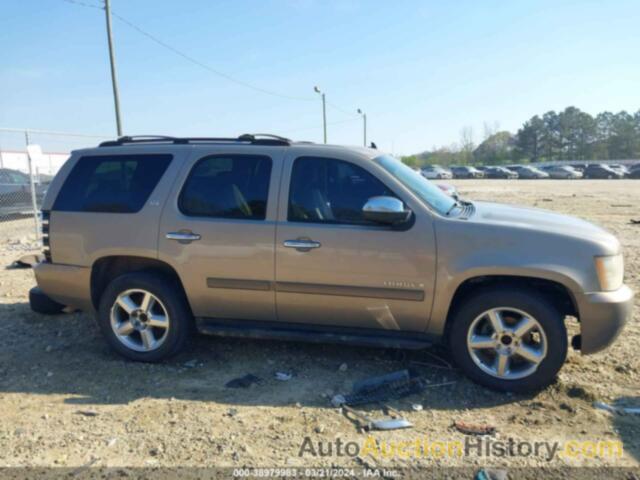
420 163 640 180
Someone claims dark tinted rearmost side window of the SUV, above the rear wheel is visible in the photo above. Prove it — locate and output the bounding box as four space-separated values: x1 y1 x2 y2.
53 155 172 213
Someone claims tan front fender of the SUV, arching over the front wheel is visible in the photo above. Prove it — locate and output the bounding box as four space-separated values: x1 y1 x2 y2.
427 220 598 334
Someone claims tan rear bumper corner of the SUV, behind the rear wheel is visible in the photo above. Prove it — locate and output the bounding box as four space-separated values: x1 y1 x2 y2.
33 262 93 311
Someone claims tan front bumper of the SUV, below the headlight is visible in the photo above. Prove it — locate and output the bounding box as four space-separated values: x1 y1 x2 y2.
575 285 633 354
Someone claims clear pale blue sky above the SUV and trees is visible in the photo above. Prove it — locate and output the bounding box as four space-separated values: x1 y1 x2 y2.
0 0 640 155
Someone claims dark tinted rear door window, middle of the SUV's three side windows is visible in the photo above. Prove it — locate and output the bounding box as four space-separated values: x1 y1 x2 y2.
178 155 271 220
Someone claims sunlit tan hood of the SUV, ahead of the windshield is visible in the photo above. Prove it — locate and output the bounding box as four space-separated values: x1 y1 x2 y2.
469 202 620 254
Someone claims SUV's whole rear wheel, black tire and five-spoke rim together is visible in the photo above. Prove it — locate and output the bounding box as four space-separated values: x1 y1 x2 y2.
98 273 193 362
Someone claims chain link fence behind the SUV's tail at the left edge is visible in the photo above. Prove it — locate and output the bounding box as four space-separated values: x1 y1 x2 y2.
0 128 110 255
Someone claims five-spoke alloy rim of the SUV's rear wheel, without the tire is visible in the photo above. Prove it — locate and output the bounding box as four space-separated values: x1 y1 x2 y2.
110 289 170 352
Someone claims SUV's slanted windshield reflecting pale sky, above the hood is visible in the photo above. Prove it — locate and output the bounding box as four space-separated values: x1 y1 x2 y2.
374 155 456 215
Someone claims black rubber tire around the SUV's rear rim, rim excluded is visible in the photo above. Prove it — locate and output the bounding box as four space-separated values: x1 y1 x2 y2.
97 272 194 362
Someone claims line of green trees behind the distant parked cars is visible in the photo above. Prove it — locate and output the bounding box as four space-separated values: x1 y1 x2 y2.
403 107 640 167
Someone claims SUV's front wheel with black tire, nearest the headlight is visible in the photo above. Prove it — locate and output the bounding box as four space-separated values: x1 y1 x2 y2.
449 288 568 392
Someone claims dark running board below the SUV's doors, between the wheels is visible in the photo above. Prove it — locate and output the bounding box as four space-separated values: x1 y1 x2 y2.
196 318 433 350
